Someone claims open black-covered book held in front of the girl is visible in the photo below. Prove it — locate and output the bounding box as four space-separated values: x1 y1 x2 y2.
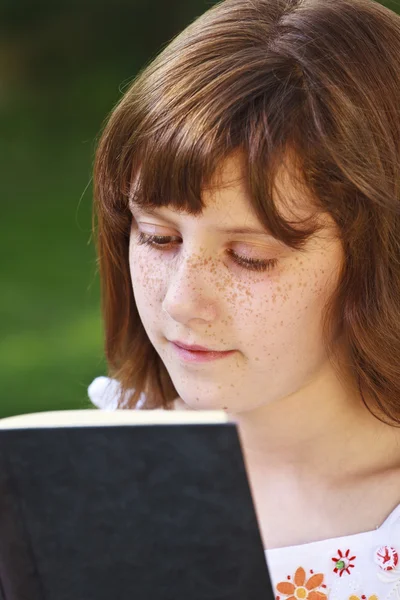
0 409 274 600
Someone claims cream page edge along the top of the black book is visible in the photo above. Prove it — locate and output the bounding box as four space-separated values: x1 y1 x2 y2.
0 409 230 429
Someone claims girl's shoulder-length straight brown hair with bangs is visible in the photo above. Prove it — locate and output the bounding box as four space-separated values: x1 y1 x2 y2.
94 0 400 423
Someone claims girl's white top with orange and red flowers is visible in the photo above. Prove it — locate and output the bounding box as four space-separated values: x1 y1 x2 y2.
88 377 400 600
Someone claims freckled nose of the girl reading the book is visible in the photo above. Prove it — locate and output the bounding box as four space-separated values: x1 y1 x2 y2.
162 257 217 325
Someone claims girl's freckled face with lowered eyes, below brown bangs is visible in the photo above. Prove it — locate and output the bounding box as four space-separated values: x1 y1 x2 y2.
129 158 343 413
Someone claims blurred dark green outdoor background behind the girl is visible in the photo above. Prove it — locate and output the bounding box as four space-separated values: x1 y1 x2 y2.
0 0 400 417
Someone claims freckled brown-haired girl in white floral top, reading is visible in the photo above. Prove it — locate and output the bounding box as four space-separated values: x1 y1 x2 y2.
89 0 400 600
